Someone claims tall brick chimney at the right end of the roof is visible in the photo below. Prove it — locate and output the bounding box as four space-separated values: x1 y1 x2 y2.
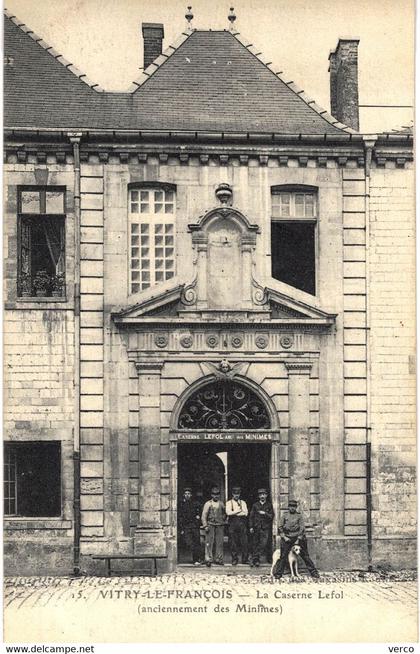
328 39 360 131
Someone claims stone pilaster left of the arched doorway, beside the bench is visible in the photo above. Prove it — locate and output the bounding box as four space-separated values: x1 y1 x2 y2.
134 361 166 555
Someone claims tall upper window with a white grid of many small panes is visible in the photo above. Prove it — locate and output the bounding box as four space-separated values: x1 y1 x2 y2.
128 184 176 293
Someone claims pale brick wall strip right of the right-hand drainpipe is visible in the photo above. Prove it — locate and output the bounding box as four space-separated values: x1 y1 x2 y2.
369 163 416 536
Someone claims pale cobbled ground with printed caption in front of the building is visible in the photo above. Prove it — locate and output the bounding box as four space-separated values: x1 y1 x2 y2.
4 568 417 642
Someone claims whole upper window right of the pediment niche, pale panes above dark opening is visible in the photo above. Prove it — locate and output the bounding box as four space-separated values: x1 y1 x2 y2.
271 186 318 295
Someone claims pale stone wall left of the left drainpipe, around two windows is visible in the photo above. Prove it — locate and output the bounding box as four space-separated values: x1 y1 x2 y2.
3 163 74 574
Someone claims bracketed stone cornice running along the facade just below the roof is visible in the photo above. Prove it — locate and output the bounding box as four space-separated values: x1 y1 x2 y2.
4 126 413 161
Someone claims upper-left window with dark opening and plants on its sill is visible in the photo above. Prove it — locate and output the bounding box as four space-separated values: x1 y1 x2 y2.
18 187 65 297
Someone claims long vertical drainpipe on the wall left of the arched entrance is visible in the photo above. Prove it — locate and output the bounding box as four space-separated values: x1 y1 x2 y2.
68 132 82 576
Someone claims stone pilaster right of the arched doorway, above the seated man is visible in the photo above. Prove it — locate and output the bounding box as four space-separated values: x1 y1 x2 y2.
286 361 312 519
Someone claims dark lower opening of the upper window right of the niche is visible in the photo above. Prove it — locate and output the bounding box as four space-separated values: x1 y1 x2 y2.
271 221 315 295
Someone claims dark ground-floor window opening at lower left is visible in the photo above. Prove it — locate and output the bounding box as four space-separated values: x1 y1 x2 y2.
4 441 61 518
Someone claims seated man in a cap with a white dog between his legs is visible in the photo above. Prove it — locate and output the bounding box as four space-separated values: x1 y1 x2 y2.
273 500 319 579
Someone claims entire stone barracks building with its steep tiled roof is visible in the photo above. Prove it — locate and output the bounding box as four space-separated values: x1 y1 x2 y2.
4 9 416 574
